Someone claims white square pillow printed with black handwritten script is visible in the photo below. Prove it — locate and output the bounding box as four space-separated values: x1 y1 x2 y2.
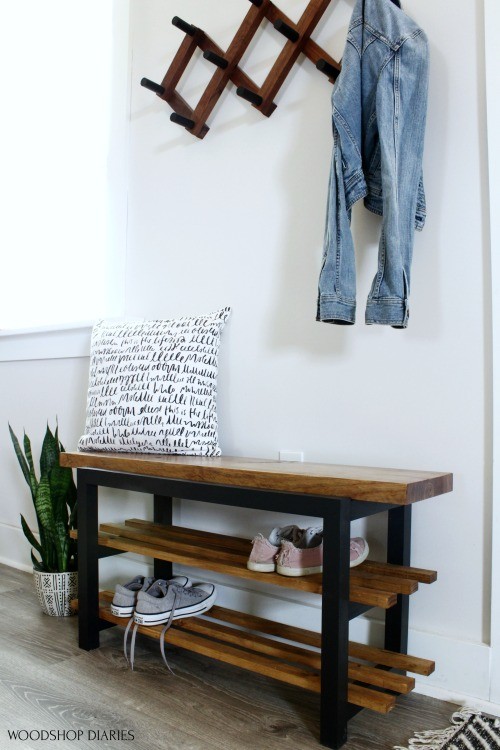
78 307 231 456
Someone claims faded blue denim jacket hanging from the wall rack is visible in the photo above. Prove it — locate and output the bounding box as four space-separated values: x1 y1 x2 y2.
317 0 429 328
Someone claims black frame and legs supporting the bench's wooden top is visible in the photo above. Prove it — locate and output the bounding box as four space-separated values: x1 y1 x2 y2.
77 469 411 750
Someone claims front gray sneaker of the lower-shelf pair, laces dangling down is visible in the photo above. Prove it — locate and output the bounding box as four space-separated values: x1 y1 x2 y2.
125 580 216 674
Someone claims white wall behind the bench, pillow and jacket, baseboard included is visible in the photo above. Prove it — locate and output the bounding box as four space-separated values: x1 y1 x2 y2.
0 0 492 712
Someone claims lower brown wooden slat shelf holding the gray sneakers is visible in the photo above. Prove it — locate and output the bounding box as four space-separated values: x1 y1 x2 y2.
95 591 434 713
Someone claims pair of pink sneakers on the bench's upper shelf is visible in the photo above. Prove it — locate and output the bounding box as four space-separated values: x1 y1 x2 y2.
247 526 369 576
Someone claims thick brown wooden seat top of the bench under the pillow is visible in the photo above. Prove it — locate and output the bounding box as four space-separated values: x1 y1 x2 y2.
61 451 453 505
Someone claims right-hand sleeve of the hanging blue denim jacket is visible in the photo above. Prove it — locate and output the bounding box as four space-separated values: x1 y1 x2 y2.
366 30 428 328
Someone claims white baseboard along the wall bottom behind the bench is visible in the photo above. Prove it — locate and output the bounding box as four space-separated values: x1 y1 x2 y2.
0 523 500 714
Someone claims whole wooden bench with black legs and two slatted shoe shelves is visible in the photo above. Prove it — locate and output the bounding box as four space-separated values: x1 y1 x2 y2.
61 452 452 748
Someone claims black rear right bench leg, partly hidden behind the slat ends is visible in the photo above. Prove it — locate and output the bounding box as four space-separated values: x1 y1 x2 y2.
385 505 411 654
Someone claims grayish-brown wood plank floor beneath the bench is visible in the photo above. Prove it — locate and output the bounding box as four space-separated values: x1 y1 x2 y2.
0 565 456 750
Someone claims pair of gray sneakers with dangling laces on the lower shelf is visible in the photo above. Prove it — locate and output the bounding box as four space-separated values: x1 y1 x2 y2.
111 576 216 674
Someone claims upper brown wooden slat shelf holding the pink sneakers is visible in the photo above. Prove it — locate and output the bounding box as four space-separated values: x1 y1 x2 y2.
70 518 436 609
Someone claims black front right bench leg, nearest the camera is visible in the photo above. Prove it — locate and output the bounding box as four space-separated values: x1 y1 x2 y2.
320 498 350 750
